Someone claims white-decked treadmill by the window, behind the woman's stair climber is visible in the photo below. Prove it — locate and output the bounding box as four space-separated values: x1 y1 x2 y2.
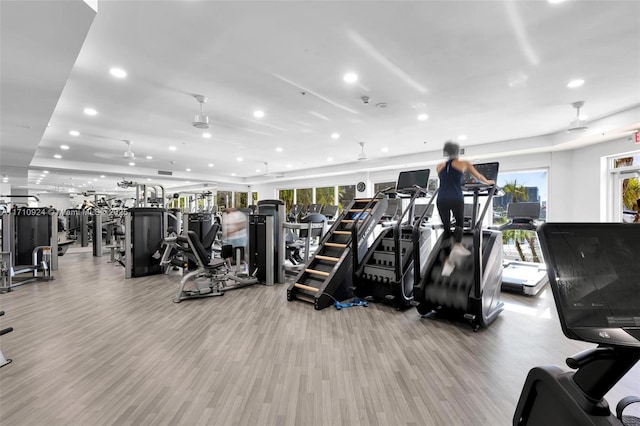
500 202 549 296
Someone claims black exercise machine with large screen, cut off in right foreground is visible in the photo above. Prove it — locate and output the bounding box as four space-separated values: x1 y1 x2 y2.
513 223 640 426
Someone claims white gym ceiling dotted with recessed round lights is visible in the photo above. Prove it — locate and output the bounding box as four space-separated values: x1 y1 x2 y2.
0 0 640 196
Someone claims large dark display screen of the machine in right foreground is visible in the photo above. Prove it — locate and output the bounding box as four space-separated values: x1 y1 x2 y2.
538 223 640 347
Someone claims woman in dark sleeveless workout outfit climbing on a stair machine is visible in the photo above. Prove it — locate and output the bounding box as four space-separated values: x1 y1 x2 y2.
436 141 495 275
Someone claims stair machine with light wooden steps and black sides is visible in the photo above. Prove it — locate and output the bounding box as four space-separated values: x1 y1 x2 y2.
287 188 391 310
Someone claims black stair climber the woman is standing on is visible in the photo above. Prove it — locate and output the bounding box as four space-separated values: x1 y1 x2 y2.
413 163 504 331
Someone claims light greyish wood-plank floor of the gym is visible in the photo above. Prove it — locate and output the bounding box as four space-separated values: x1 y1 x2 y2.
0 253 640 426
